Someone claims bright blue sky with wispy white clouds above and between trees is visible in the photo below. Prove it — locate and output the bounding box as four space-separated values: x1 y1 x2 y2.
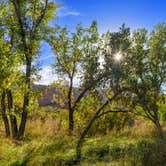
36 0 166 84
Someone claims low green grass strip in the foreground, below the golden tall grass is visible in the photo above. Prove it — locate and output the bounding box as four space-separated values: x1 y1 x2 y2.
0 135 166 166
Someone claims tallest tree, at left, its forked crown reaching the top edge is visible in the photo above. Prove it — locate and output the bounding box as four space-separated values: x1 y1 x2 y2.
1 0 56 139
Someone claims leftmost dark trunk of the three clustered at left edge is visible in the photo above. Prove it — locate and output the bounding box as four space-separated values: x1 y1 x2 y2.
1 91 10 137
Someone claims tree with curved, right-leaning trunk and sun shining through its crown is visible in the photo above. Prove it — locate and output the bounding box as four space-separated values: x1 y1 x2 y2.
76 25 133 162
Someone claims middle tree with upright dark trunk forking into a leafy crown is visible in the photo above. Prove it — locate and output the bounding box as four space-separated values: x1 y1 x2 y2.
50 22 103 133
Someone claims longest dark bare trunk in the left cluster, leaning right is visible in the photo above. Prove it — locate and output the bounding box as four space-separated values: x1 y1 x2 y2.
18 57 31 139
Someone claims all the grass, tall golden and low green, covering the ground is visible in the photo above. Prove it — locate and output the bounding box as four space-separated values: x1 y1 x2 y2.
0 119 166 166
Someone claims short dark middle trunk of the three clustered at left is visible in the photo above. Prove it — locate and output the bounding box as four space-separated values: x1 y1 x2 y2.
7 90 18 139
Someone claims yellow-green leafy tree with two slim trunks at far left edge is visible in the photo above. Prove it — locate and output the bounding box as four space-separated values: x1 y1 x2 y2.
0 14 20 138
